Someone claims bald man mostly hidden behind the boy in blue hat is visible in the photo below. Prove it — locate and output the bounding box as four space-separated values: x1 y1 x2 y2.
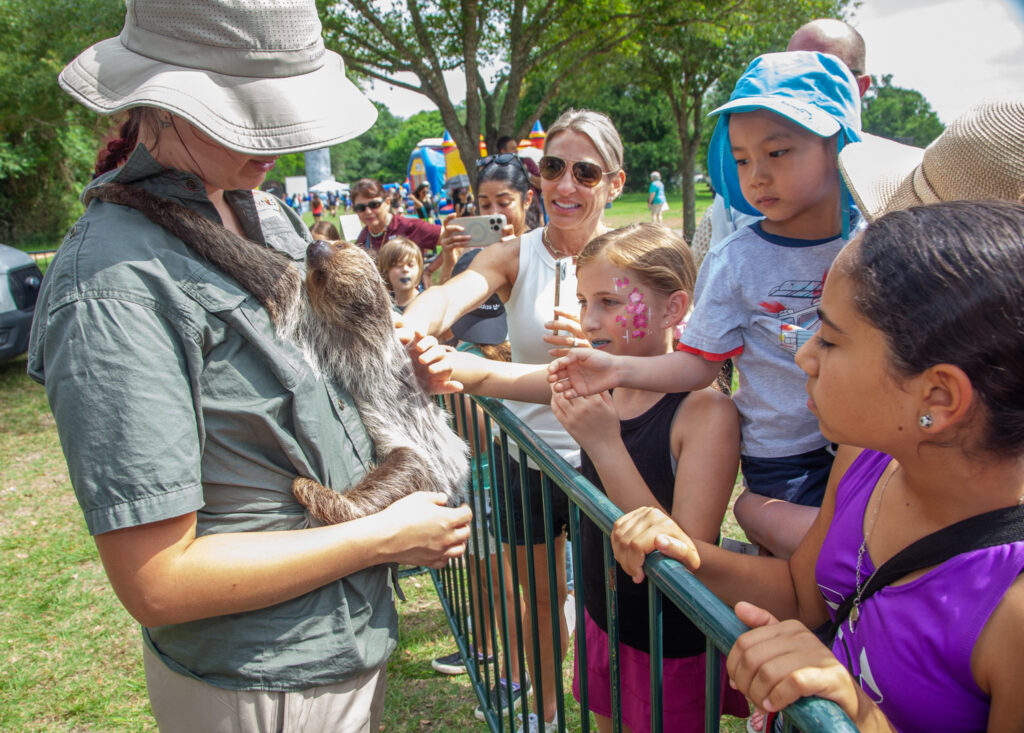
692 17 871 257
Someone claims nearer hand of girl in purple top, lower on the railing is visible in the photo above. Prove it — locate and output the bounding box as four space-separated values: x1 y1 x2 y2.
726 602 866 721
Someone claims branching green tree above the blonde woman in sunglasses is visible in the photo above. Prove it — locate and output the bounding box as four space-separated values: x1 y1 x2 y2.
317 0 635 189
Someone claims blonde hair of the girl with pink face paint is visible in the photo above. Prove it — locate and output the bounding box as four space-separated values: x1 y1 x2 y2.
577 223 697 298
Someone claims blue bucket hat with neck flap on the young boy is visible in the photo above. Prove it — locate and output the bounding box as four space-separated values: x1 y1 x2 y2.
708 51 860 238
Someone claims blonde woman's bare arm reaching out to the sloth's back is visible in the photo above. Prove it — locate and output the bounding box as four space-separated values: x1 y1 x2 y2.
398 239 516 335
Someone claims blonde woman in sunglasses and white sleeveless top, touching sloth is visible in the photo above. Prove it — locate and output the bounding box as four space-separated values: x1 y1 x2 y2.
402 110 626 731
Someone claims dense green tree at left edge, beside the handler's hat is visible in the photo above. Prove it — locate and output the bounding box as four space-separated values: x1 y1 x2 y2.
0 0 124 242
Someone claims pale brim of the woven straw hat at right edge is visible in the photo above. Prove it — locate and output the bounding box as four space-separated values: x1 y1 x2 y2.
839 135 925 221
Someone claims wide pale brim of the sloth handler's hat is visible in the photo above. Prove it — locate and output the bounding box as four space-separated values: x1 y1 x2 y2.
59 38 377 156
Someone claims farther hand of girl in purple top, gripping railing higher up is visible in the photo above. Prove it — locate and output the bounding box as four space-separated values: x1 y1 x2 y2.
611 507 700 583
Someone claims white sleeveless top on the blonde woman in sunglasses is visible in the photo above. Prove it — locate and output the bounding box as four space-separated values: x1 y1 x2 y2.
505 228 580 468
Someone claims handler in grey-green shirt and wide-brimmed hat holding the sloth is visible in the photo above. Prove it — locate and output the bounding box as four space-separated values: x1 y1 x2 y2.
29 0 470 733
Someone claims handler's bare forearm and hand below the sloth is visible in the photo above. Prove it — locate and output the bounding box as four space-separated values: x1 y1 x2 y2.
95 492 471 627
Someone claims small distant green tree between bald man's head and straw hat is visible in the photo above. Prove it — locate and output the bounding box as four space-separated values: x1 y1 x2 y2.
861 74 945 147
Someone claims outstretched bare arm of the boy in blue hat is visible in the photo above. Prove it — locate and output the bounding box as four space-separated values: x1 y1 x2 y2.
548 349 722 397
